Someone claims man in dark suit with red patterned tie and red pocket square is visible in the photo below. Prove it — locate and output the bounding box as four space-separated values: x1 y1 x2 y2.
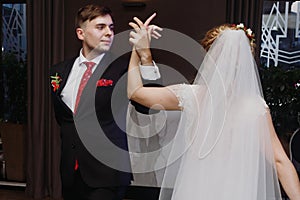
50 5 160 200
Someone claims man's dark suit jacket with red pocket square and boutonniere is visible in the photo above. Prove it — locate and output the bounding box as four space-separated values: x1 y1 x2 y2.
50 53 132 187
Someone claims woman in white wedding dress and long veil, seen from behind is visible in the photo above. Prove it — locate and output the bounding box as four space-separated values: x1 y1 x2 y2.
128 18 300 200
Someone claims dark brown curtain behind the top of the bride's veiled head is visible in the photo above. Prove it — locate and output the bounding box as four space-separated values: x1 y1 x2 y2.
226 0 264 61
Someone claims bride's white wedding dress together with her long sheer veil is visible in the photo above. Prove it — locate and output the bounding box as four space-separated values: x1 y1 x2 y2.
160 30 281 200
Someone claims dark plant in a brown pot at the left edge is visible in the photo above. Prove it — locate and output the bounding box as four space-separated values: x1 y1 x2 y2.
0 53 27 182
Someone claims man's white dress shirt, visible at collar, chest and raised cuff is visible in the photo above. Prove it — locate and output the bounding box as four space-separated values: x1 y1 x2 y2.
61 49 160 112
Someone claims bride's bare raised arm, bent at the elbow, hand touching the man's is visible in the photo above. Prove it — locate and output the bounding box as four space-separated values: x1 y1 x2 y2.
127 17 180 110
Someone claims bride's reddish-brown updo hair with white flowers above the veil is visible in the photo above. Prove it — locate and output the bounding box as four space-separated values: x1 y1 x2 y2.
200 23 256 54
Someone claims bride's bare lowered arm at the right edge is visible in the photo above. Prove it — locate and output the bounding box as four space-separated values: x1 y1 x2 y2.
267 112 300 200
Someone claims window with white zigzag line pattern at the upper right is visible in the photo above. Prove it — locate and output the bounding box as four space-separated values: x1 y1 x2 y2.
260 1 300 67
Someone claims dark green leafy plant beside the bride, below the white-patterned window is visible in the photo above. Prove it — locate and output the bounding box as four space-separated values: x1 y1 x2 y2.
260 67 300 135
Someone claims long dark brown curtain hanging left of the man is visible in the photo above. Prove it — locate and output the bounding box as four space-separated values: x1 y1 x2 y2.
26 0 64 199
